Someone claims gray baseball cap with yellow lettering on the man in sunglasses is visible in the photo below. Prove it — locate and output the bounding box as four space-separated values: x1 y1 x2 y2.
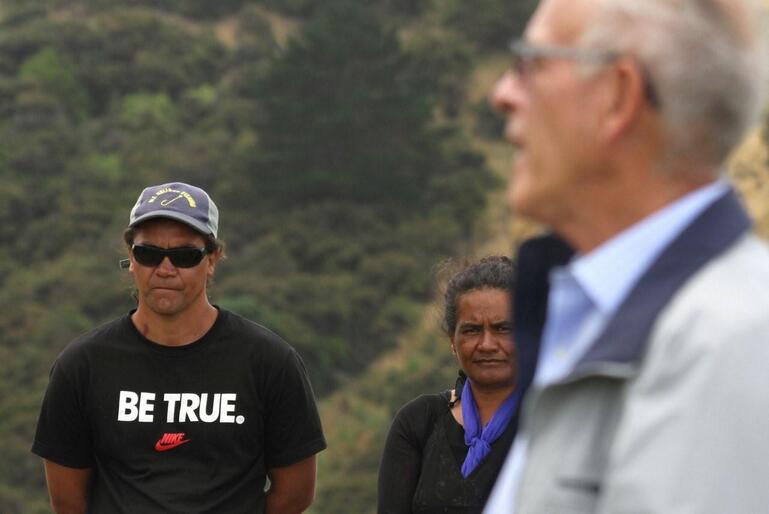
128 182 219 237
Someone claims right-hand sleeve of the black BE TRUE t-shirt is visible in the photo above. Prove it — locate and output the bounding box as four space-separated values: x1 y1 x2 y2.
265 349 326 469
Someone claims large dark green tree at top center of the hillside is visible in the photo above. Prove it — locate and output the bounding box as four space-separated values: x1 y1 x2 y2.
244 1 440 218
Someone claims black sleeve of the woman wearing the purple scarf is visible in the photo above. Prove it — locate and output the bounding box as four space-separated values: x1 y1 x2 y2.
377 396 434 514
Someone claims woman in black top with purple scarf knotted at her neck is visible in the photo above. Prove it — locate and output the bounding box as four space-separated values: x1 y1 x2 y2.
377 257 520 514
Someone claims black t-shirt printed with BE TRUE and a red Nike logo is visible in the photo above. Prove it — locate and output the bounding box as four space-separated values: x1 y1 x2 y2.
32 310 326 514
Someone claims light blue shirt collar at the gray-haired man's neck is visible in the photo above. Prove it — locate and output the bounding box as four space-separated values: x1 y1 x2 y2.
568 179 729 314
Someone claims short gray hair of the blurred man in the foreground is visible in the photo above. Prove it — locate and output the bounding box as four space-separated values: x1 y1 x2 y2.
581 0 769 170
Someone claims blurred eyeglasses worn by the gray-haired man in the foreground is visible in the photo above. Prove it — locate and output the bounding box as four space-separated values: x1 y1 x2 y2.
509 39 660 107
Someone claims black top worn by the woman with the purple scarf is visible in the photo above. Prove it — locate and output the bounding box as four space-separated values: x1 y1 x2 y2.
377 391 517 514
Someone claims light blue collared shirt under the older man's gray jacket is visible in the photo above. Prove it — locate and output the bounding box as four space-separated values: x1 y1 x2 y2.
483 180 730 514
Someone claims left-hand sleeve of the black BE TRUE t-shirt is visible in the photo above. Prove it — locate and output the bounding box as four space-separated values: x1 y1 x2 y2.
32 360 93 468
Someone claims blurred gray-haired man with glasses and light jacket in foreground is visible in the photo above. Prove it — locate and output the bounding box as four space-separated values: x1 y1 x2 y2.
485 0 769 514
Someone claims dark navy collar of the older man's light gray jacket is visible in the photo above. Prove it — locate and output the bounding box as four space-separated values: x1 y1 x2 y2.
514 190 750 380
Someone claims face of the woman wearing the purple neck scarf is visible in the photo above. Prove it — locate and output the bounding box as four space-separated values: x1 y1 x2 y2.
451 288 518 389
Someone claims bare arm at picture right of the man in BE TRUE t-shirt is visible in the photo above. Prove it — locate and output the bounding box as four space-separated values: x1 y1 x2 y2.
266 455 317 514
